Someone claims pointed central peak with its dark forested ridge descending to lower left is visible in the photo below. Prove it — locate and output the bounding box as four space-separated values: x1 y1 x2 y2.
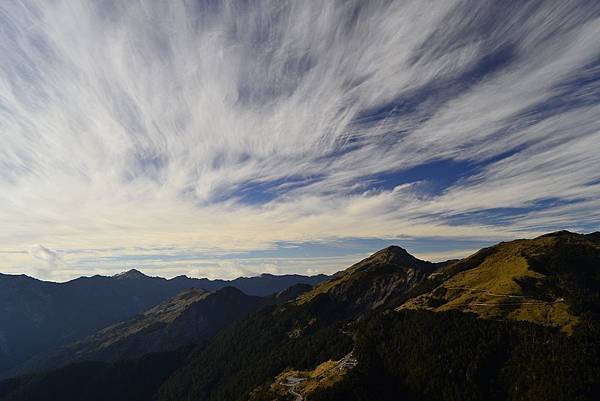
159 246 436 401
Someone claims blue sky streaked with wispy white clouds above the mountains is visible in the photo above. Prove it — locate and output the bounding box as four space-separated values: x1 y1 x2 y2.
0 0 600 281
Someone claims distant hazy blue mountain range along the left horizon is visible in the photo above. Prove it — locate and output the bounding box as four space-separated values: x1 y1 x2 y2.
0 269 326 377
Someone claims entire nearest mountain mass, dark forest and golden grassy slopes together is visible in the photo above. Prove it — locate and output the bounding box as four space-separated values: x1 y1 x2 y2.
0 232 600 401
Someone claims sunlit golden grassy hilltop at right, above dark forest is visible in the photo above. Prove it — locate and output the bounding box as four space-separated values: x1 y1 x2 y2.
398 232 600 332
